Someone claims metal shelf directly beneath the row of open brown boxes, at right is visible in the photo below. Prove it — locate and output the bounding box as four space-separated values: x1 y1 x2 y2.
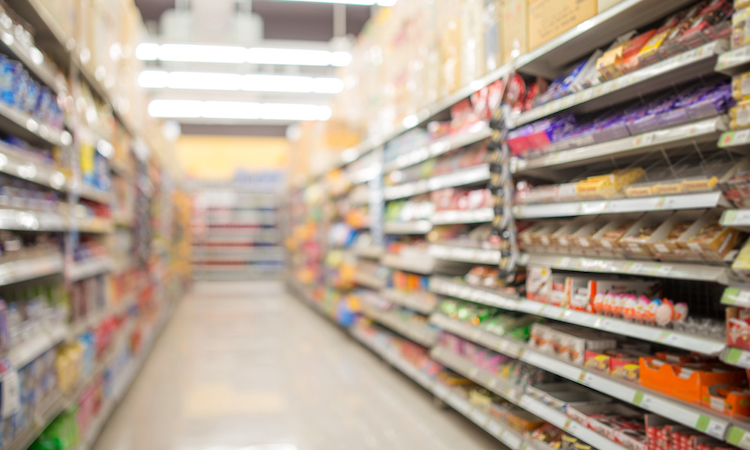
521 253 728 283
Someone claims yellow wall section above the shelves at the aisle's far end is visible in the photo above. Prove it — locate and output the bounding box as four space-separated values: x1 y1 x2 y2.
177 135 289 180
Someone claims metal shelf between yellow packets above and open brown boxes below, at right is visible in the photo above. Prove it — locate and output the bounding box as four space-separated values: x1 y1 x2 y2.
513 191 728 219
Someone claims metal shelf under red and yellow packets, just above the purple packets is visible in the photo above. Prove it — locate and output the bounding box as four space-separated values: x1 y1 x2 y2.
513 39 729 127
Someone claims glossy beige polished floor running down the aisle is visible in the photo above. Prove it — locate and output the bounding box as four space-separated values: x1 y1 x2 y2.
94 281 503 450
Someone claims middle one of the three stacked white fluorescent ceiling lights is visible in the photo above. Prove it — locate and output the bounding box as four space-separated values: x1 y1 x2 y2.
138 70 344 94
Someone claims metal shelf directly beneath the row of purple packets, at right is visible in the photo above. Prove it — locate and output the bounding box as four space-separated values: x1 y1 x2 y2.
513 116 727 178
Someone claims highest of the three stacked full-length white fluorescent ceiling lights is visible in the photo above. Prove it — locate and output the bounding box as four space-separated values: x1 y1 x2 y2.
135 43 352 67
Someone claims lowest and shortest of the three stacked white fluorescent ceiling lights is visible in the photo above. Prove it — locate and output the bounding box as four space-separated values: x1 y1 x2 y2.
148 100 331 121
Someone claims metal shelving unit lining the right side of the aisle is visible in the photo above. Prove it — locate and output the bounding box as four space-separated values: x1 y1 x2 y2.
288 0 750 449
